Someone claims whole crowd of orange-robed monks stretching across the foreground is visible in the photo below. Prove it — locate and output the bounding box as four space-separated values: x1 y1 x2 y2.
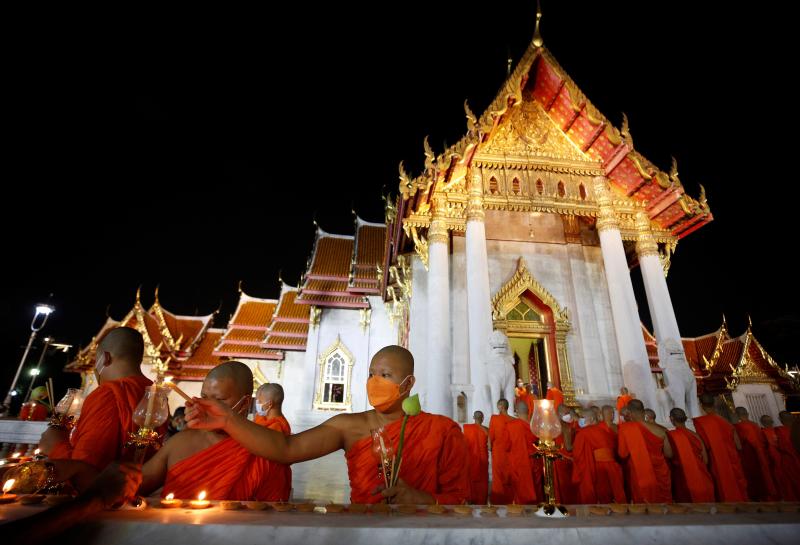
25 327 800 504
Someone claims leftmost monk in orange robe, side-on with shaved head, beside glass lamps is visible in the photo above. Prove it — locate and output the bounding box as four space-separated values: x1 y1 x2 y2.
39 327 159 470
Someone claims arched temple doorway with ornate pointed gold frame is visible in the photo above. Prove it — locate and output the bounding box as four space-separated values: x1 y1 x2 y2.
492 257 574 403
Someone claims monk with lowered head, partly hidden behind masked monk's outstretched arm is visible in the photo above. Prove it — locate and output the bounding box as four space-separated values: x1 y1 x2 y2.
51 361 291 501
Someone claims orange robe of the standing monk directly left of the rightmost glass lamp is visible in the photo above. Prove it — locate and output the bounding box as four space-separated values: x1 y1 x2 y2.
506 418 542 505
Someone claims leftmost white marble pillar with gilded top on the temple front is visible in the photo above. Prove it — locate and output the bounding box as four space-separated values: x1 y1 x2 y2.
425 196 453 417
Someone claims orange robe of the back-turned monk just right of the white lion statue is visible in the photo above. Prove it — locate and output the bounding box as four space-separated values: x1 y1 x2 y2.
693 414 748 502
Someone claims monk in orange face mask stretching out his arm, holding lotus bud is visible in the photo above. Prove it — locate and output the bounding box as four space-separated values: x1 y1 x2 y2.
186 345 469 504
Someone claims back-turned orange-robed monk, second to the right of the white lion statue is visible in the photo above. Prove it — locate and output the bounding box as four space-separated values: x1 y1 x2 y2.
733 407 778 501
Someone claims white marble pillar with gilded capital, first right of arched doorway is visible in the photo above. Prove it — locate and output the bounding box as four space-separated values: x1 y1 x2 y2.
594 176 658 409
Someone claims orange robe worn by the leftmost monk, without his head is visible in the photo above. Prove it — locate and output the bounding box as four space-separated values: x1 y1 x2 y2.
50 375 158 470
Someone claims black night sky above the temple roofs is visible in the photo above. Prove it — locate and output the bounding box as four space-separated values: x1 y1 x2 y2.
0 1 800 404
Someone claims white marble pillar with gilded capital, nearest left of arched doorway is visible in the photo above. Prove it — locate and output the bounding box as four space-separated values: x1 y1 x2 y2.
466 169 492 415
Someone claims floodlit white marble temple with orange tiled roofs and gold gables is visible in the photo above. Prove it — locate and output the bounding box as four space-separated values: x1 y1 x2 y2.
67 10 798 422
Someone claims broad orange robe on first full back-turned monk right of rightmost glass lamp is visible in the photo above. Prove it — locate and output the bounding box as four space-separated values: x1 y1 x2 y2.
572 424 628 503
